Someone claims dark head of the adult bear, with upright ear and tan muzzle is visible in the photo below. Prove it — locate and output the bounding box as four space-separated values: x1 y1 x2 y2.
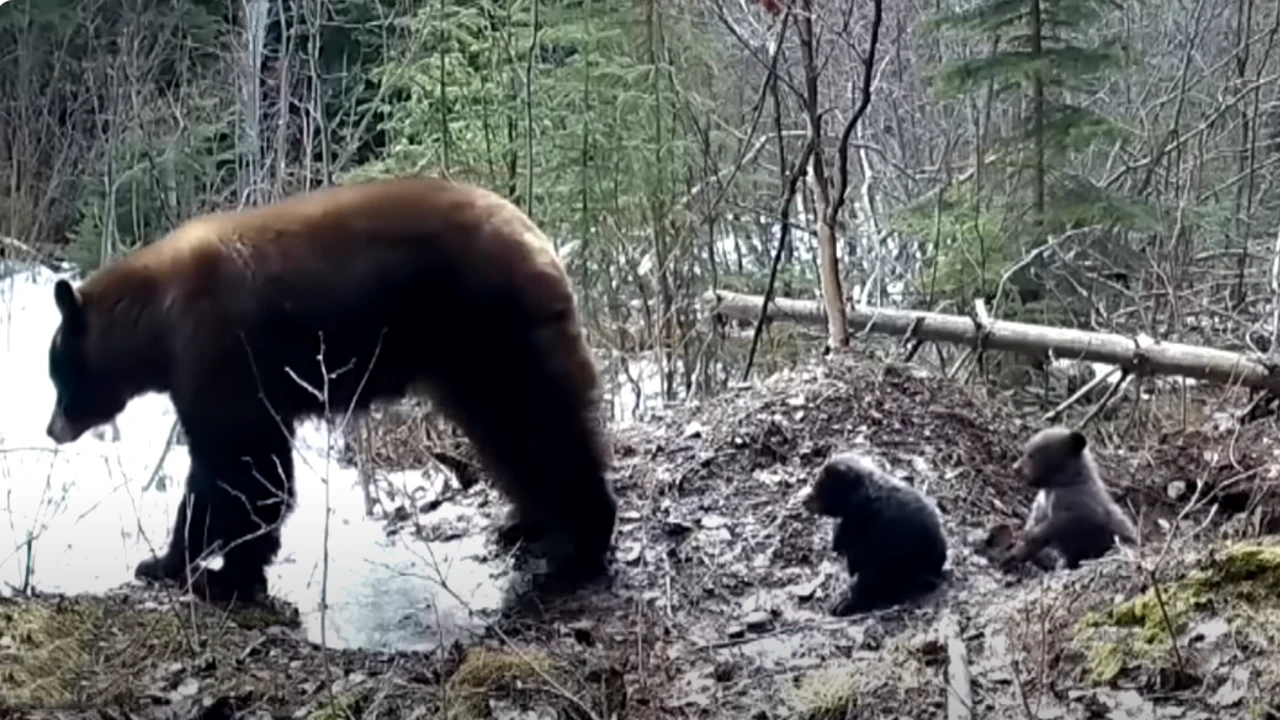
45 279 128 445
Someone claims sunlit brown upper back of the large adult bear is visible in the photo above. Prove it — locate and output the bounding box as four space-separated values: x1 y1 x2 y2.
101 178 571 313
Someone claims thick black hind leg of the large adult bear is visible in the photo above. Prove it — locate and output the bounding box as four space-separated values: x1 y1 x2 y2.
439 322 617 588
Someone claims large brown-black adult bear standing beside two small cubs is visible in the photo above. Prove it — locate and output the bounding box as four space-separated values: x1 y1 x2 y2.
46 178 617 601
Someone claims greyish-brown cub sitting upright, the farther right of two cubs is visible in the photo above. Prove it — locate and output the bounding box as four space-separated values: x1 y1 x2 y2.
1001 427 1138 569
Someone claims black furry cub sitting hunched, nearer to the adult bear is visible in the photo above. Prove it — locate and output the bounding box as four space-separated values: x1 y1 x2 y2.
804 452 947 616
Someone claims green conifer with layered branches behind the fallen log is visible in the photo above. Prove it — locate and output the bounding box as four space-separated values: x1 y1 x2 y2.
916 0 1158 308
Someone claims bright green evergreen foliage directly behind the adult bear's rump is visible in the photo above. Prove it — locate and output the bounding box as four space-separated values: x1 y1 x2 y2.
350 0 739 330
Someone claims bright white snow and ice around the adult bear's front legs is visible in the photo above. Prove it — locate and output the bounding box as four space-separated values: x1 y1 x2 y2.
0 263 506 650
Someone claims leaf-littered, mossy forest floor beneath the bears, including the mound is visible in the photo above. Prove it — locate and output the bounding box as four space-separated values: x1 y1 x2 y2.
0 357 1280 720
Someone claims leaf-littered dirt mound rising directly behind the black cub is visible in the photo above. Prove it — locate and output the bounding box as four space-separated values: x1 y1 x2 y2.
618 357 1032 525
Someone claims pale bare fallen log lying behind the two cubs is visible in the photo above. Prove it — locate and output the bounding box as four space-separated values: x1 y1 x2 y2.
703 290 1280 392
